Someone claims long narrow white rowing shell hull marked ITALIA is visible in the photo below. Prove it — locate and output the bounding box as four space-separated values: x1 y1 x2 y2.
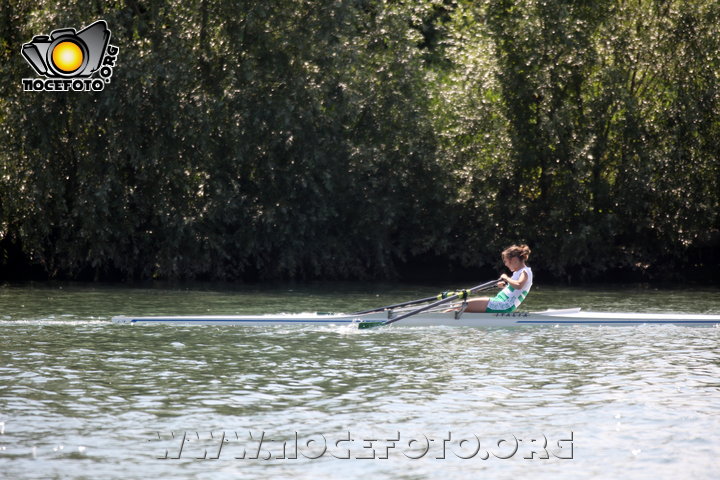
112 308 720 327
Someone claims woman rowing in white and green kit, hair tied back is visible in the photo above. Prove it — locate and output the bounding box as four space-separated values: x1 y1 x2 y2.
465 245 532 313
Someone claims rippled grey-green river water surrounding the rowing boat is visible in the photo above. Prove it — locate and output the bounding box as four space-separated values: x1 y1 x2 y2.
0 283 720 479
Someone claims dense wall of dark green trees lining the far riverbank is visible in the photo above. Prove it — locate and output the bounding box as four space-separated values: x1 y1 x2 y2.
0 0 720 280
